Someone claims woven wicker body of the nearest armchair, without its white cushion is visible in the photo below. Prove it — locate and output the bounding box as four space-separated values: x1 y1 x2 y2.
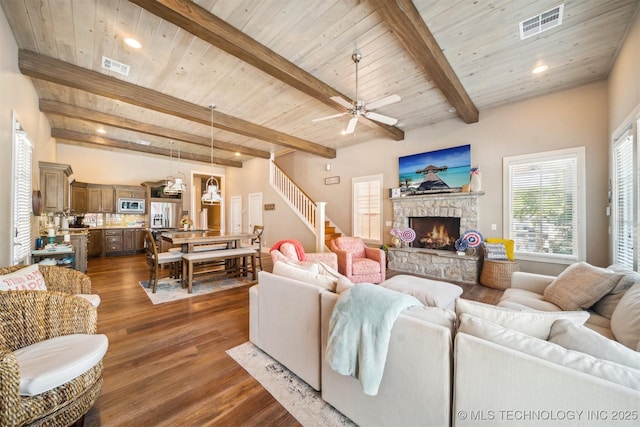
0 292 102 426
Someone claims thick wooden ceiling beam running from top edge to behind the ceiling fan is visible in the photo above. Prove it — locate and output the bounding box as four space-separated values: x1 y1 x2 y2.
129 0 404 141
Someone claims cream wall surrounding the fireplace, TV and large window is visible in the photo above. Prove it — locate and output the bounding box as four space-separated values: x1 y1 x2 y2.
277 82 608 274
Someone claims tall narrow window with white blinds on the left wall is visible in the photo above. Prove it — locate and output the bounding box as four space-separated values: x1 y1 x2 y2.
13 118 32 264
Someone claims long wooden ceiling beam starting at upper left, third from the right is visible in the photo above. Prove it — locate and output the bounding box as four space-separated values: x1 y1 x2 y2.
18 49 336 159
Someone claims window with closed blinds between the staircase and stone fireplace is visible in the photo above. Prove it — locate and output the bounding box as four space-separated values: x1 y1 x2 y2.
352 175 382 244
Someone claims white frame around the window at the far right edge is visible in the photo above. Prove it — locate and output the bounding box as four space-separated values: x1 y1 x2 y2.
609 117 640 270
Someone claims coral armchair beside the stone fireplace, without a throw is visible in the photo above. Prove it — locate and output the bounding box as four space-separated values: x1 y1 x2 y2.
331 237 386 283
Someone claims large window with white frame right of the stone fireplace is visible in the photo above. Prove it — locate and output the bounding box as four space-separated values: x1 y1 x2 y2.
503 147 586 263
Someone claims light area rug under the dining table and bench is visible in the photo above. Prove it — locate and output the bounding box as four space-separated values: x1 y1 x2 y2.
139 277 258 305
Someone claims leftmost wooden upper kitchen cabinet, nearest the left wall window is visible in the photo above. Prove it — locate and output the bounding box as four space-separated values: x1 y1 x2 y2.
39 162 73 212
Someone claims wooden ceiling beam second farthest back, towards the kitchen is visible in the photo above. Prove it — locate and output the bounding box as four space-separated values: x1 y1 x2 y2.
40 99 271 159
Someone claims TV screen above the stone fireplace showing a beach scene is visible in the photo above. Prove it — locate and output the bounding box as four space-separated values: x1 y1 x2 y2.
398 145 471 194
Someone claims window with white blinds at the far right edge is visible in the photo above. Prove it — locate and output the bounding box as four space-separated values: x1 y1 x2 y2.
610 121 638 269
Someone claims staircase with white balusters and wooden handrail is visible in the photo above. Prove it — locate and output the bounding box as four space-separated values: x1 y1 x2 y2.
269 160 342 252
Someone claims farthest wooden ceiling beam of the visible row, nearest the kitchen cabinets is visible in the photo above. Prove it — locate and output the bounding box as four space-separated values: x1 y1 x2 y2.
51 128 242 168
